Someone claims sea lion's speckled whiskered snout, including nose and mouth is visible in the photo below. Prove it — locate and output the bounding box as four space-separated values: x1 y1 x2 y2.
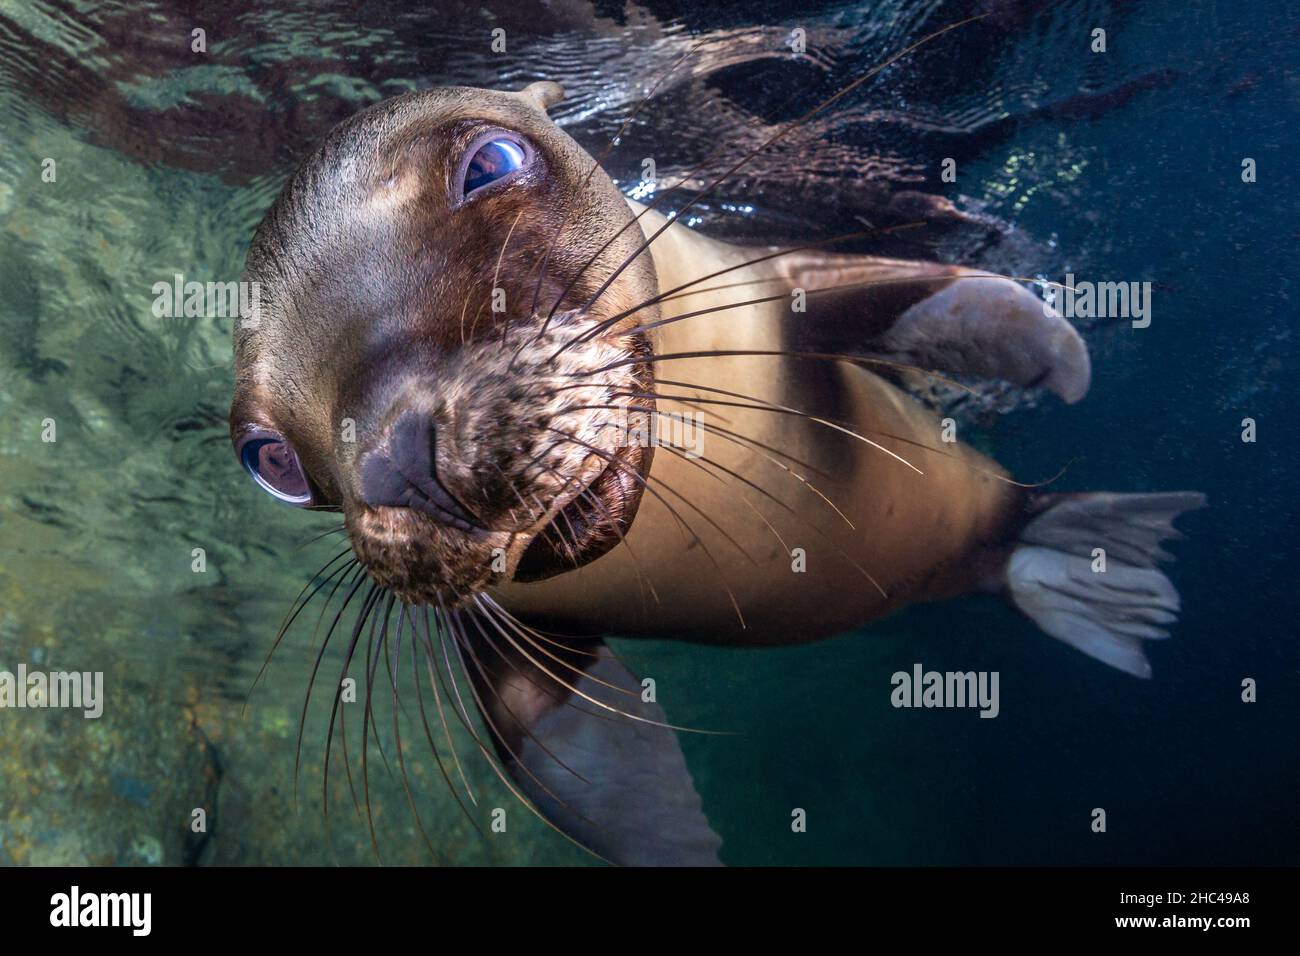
332 321 649 605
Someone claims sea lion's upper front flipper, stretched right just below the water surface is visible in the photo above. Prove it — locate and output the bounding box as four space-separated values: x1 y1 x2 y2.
775 252 1092 402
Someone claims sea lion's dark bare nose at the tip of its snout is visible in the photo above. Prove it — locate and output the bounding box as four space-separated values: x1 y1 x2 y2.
359 410 482 531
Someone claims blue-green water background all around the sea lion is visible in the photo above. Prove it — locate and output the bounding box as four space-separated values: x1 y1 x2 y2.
0 0 1300 864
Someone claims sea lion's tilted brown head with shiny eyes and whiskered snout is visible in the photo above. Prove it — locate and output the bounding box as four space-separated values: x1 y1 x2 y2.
230 83 657 605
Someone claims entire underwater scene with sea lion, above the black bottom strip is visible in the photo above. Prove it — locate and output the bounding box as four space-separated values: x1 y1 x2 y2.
0 0 1300 866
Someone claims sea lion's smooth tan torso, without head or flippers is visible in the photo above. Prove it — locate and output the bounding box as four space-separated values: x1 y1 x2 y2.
494 204 1024 645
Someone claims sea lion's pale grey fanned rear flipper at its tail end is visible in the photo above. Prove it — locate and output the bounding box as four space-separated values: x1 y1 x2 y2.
1006 492 1205 678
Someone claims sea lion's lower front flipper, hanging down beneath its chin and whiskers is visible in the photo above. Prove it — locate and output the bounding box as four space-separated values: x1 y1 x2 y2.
465 624 722 866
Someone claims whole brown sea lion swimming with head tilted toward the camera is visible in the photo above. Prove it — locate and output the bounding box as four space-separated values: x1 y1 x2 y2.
230 83 1201 864
